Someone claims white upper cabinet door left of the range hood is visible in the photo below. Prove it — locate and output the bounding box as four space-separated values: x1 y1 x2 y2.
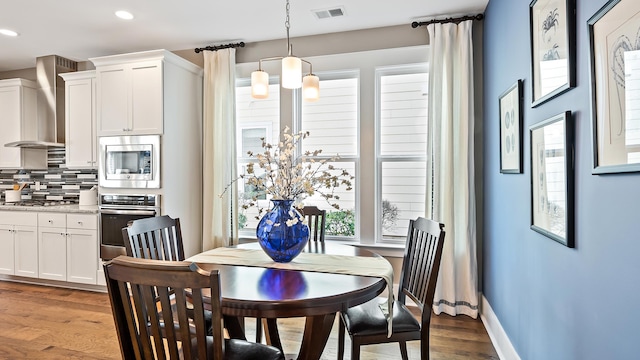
0 86 22 168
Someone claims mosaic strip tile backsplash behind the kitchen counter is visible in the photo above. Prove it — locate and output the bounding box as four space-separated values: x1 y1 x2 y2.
0 149 98 203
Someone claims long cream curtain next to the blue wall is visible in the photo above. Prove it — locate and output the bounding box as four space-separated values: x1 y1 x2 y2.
427 20 478 318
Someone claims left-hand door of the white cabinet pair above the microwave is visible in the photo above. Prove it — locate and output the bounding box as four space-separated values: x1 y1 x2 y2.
96 66 131 136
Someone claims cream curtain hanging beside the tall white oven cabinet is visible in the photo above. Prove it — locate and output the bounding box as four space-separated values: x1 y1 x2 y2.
202 48 238 251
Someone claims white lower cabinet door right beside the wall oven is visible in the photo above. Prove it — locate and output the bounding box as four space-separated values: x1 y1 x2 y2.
67 229 98 285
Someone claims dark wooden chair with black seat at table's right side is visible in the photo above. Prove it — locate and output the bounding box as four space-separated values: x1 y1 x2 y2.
338 218 445 360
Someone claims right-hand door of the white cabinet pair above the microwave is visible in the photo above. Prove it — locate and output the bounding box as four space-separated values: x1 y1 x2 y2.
131 60 163 135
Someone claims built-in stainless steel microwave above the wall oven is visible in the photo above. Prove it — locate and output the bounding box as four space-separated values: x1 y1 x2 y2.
98 135 160 189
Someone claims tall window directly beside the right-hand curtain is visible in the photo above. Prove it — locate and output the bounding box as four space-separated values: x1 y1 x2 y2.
376 65 428 240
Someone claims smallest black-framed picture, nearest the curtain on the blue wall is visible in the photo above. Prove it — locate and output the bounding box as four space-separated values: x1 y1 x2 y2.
498 80 523 174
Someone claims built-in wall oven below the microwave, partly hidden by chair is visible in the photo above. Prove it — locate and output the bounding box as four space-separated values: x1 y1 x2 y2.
98 194 160 260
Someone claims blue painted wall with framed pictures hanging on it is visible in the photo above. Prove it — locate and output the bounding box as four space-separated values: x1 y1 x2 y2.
482 0 640 360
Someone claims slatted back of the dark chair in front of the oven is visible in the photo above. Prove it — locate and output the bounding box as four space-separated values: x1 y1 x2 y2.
122 215 185 261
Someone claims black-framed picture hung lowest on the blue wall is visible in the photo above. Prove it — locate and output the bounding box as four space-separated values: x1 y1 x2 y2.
529 111 574 247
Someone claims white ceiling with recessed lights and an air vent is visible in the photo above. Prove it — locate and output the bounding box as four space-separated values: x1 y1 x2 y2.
0 0 489 71
